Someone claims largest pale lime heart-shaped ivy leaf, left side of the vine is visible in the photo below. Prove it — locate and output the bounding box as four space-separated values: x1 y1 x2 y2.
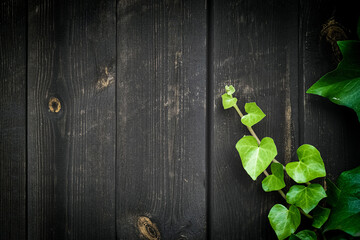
236 136 277 181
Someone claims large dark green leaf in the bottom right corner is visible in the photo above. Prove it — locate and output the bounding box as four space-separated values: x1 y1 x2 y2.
325 166 360 237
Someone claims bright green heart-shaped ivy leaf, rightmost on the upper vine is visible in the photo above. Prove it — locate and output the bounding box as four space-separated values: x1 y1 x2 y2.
286 144 326 183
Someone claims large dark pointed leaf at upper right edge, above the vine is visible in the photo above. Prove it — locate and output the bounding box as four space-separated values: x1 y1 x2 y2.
307 40 360 121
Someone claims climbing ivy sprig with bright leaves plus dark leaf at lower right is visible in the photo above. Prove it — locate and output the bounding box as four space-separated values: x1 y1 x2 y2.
222 86 360 240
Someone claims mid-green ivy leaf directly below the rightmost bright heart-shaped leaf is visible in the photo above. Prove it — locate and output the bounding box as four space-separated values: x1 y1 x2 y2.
286 184 326 213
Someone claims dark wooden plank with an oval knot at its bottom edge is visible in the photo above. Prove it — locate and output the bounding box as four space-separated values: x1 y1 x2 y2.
116 0 206 239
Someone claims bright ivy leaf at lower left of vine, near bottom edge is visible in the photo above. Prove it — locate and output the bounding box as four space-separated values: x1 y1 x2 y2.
268 204 301 240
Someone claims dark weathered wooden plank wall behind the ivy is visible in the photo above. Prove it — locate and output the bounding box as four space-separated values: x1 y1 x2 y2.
0 0 360 240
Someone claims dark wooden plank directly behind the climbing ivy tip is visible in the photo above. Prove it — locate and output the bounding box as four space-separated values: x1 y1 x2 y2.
210 0 298 239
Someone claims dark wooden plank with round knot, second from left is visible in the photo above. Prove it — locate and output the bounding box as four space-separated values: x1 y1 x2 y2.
28 0 116 239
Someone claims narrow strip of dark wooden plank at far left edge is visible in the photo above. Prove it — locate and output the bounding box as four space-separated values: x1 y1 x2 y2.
0 0 27 240
